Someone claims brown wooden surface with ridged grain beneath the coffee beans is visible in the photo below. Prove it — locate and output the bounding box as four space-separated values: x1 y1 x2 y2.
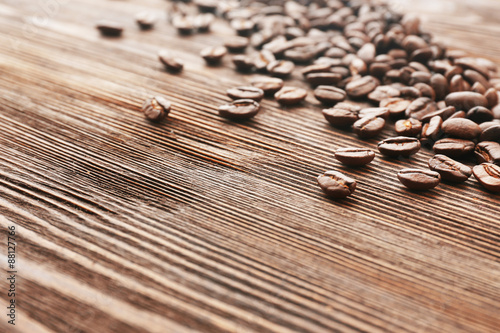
0 0 500 333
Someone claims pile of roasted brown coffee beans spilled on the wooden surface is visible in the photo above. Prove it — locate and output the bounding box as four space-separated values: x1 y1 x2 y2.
133 0 500 198
